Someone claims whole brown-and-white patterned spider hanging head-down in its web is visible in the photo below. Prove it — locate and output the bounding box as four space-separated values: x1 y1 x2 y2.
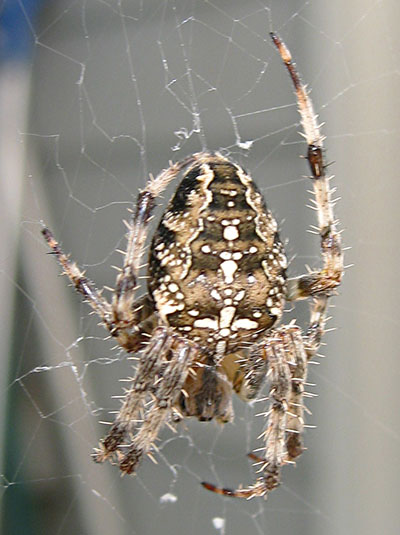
42 33 343 499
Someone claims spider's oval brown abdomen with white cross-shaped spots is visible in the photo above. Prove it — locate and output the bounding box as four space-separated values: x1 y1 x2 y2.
149 155 287 353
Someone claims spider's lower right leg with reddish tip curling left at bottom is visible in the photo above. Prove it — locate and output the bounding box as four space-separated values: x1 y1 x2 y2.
202 327 296 499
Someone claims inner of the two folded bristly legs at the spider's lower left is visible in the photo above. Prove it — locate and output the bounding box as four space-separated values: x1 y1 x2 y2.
118 334 198 474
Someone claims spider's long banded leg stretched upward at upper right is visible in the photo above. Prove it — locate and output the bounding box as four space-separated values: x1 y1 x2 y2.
271 33 343 300
